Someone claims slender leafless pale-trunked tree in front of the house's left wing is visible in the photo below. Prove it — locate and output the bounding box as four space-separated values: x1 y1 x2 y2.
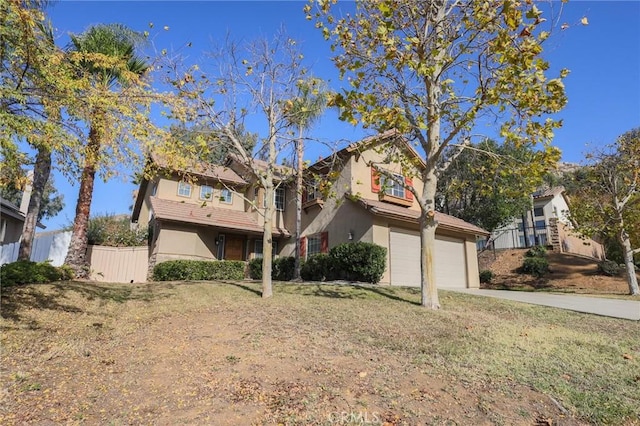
167 31 307 298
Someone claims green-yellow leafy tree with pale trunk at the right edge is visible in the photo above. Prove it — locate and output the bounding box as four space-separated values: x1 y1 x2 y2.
569 128 640 295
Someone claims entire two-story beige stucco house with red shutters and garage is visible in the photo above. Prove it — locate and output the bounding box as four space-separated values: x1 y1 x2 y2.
132 131 487 288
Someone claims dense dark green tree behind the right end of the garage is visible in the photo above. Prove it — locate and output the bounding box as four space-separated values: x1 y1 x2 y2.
436 139 560 232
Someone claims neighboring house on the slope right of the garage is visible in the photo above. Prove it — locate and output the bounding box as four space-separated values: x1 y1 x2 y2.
491 186 604 259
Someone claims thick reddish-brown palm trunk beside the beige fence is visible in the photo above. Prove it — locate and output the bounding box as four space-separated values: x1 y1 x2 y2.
64 120 102 278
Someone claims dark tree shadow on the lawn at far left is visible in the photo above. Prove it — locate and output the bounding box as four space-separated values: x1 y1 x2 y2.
0 281 174 328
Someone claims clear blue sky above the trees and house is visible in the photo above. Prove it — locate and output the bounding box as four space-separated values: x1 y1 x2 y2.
37 0 640 230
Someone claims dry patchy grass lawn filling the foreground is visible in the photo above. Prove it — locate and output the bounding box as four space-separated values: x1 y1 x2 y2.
0 282 640 425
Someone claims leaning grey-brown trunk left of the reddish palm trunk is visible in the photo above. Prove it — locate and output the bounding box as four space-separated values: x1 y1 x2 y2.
18 146 51 260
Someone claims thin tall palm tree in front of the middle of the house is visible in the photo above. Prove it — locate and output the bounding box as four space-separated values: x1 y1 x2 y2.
288 78 328 280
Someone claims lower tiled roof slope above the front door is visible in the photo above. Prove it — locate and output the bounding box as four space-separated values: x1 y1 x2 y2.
150 197 291 237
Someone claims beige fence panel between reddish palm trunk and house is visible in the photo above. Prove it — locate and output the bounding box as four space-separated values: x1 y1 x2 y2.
87 246 149 283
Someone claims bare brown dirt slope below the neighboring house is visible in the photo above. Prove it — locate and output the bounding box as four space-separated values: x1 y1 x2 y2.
478 249 629 296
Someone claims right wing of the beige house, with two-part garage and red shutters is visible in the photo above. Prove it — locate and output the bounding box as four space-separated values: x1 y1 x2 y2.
281 131 488 288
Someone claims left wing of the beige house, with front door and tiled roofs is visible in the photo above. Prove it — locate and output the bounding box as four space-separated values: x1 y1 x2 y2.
131 153 295 270
